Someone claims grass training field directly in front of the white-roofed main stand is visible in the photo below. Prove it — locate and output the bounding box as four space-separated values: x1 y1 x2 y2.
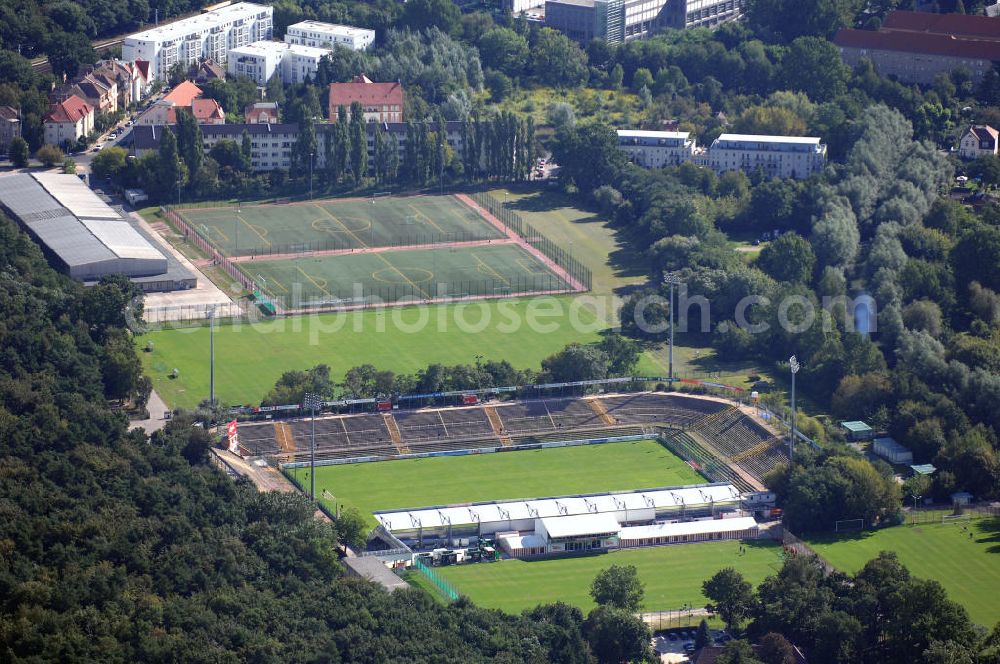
434 540 781 613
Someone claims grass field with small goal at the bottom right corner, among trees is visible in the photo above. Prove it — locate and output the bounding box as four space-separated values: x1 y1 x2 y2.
809 519 1000 628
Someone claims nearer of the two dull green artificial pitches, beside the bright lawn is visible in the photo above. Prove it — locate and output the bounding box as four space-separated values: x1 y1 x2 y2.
237 242 571 309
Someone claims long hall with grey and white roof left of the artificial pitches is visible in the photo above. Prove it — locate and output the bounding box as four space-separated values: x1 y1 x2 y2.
0 173 195 290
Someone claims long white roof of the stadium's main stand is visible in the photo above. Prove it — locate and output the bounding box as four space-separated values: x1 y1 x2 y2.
375 484 740 531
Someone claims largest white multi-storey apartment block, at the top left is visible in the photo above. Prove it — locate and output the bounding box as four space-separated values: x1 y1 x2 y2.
122 2 273 81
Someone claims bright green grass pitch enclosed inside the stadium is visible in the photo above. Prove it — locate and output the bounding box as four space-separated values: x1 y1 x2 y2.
298 440 707 523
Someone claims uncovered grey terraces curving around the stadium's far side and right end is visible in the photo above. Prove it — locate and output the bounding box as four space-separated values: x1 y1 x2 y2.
240 392 787 491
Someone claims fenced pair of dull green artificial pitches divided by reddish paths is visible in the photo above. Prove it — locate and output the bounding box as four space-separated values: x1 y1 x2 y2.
165 189 591 313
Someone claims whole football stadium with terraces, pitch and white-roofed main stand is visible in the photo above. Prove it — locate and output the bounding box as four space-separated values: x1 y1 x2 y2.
239 392 787 588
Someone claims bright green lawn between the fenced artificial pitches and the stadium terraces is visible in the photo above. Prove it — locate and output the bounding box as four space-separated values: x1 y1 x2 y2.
136 296 603 408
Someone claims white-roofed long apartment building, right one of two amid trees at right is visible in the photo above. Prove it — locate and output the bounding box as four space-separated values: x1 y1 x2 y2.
712 134 826 180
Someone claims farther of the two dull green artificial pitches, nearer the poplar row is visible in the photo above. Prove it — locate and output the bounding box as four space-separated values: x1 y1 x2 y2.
175 196 503 256
